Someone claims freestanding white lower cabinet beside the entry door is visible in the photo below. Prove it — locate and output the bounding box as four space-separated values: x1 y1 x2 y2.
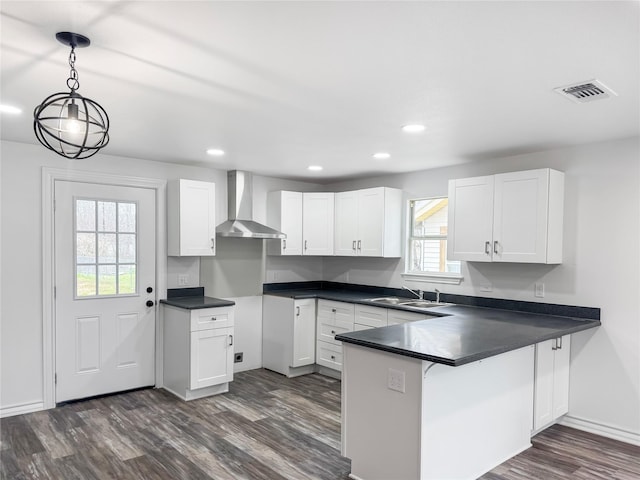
163 305 234 400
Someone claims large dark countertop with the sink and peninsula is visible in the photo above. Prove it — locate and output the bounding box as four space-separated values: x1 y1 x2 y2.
264 282 600 366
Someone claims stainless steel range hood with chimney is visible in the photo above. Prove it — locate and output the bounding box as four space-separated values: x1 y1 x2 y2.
216 170 287 238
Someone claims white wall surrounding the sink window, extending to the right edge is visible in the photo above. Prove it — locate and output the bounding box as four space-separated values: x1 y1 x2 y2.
322 138 640 442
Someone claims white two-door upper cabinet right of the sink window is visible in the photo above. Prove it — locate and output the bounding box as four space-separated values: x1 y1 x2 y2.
447 168 564 264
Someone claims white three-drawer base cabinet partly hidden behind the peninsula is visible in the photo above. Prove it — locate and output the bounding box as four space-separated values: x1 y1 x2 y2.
316 300 355 371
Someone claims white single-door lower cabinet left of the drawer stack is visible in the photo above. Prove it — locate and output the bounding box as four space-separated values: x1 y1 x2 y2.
262 295 316 377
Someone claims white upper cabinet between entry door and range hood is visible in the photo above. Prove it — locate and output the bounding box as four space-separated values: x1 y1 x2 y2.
167 179 216 257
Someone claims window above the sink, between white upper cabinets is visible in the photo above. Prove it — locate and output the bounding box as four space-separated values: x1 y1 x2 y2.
406 197 460 277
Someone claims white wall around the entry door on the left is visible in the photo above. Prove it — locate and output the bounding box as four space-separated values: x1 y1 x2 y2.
0 141 227 410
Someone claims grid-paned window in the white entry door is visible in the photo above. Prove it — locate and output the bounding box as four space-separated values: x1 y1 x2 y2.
74 199 138 298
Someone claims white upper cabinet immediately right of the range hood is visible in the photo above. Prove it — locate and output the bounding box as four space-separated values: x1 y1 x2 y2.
267 190 302 255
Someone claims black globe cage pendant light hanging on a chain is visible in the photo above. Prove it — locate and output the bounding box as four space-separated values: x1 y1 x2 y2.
33 32 109 159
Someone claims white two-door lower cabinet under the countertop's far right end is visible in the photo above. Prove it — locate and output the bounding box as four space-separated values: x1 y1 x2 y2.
533 335 571 433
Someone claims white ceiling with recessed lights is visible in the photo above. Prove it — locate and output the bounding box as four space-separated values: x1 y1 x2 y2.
0 0 640 182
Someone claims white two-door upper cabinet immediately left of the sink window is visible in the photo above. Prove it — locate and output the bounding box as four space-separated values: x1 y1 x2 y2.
335 187 402 257
